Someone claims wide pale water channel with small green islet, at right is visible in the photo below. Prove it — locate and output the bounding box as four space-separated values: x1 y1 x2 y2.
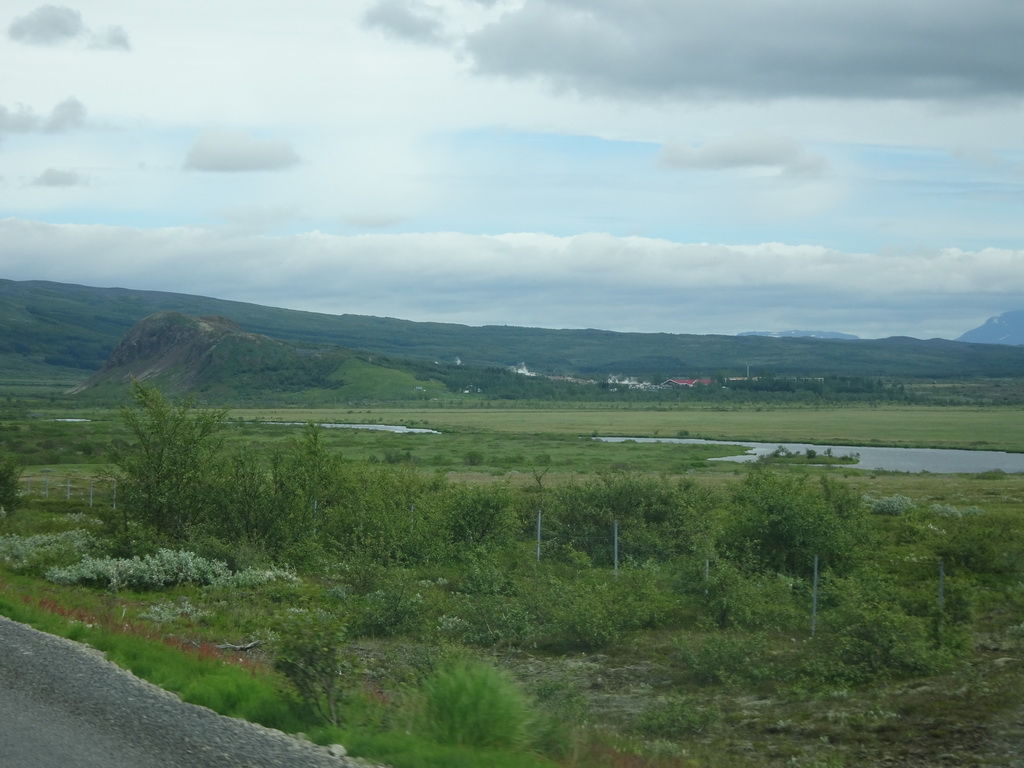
595 437 1024 474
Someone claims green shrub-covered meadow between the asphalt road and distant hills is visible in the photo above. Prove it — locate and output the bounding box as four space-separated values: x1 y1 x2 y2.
0 397 1024 768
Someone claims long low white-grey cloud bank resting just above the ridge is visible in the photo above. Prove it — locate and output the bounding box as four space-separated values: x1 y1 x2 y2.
0 219 1024 338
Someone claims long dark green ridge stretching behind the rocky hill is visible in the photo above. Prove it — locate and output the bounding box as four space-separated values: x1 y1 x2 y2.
0 280 1024 391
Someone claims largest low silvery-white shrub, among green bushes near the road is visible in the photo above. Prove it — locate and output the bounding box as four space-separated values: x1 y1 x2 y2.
46 549 295 591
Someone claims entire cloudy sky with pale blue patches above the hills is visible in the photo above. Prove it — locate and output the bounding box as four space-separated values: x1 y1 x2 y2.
0 0 1024 338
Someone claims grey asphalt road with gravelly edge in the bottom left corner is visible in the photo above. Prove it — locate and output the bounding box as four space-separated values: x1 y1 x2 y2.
0 616 374 768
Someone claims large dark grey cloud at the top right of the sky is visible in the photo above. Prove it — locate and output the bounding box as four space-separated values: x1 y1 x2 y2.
466 0 1024 99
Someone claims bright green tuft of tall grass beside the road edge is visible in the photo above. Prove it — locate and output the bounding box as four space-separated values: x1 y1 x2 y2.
419 662 532 750
